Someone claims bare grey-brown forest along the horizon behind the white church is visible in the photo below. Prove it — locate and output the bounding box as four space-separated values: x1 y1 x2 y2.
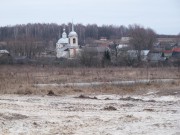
0 23 129 44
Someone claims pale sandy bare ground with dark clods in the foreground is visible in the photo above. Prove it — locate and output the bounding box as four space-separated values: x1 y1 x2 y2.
0 91 180 135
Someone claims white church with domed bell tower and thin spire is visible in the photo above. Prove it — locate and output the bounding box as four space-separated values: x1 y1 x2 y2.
56 23 80 59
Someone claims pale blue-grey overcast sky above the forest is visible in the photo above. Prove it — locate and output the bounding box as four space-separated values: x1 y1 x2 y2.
0 0 180 34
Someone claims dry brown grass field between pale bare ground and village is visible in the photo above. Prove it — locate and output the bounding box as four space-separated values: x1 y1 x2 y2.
0 65 180 95
